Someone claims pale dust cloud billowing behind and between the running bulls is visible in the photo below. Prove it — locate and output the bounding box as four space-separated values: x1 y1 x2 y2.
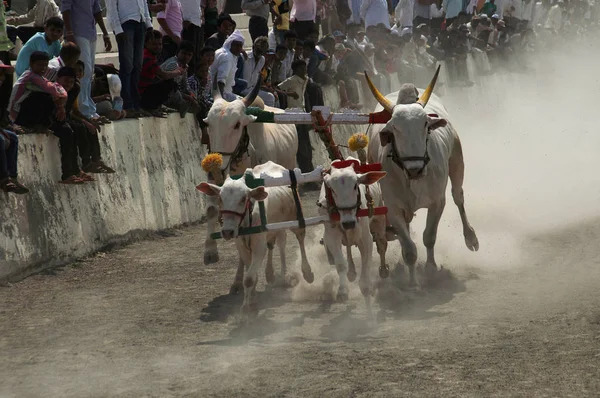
292 41 600 301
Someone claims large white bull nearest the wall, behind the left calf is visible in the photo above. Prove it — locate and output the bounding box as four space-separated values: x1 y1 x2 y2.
204 79 298 264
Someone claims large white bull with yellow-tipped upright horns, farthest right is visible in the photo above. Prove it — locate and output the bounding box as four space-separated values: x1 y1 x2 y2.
365 67 479 288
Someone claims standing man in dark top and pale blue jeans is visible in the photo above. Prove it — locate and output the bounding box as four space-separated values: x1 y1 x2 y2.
60 0 112 120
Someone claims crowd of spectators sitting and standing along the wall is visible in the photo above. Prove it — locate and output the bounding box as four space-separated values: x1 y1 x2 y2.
0 0 598 194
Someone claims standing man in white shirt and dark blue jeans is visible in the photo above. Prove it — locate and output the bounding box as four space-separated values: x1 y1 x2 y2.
106 0 153 118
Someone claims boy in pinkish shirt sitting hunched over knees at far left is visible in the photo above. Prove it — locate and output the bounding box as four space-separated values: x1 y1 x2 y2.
9 51 67 133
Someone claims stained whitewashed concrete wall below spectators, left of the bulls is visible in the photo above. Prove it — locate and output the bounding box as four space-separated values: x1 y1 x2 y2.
0 114 211 282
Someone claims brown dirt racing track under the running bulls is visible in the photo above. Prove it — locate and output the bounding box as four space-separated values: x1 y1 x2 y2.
0 189 600 397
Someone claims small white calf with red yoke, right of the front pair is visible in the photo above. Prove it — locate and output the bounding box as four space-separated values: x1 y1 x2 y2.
318 157 387 314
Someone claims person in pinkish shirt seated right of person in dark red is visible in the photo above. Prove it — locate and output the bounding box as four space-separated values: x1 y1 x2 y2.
160 40 198 118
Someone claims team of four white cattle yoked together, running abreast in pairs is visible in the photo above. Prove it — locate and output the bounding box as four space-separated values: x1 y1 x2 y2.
199 68 479 318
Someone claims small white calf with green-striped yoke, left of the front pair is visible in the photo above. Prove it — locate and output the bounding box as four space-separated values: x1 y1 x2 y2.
198 161 314 314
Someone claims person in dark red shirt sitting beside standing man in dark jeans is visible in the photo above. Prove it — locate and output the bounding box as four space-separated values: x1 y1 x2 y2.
138 30 184 117
